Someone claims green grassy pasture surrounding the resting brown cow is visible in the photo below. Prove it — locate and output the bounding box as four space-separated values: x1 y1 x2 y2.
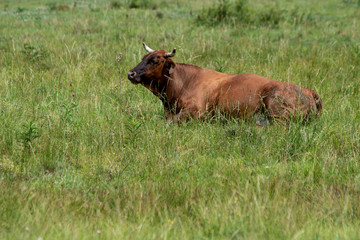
0 0 360 239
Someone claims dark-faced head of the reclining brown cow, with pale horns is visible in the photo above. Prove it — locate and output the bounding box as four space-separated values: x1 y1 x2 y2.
128 43 176 84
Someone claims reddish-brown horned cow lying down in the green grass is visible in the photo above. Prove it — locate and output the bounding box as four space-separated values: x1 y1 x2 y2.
128 43 322 125
